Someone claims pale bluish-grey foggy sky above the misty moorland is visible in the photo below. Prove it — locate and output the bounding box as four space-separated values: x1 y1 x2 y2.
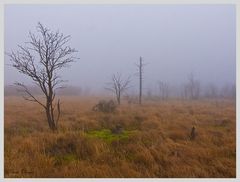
4 5 236 93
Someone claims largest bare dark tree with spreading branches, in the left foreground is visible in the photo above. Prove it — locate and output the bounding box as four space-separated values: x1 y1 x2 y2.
8 23 77 130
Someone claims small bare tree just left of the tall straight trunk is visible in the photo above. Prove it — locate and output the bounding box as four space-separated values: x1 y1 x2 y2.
106 73 130 105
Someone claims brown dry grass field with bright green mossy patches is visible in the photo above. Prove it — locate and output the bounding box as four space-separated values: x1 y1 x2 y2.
4 96 236 178
